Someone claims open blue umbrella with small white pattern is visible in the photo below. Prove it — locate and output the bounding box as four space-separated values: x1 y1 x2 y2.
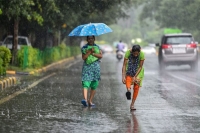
68 23 112 36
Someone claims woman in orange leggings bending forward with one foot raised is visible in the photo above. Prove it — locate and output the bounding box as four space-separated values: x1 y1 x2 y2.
122 45 145 110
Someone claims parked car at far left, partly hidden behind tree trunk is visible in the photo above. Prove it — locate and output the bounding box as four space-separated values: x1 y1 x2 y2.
1 35 31 50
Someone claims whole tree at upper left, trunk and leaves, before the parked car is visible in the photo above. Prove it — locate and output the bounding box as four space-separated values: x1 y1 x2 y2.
0 0 43 64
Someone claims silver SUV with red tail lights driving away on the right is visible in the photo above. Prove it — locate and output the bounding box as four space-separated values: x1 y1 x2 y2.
156 33 198 70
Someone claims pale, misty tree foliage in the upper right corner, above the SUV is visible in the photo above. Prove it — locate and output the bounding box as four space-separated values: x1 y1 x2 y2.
140 0 200 41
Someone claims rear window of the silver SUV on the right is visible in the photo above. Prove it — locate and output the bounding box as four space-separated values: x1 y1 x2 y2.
165 36 192 44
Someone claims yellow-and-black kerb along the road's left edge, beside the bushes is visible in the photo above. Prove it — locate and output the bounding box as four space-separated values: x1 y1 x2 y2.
0 57 77 91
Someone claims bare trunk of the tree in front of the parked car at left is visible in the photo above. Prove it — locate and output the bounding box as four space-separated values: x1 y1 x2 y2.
12 19 19 65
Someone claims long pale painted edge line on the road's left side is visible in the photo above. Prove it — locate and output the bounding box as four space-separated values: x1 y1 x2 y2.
0 73 56 105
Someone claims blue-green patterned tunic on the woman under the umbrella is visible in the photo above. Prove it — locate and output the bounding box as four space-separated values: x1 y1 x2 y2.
81 44 101 81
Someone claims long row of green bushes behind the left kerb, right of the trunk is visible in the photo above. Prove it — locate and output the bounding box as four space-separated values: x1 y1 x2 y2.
14 44 80 69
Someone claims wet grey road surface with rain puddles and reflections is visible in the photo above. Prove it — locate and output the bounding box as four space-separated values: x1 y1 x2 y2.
0 54 200 133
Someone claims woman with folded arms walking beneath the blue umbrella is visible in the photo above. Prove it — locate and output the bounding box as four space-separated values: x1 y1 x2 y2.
81 36 102 106
